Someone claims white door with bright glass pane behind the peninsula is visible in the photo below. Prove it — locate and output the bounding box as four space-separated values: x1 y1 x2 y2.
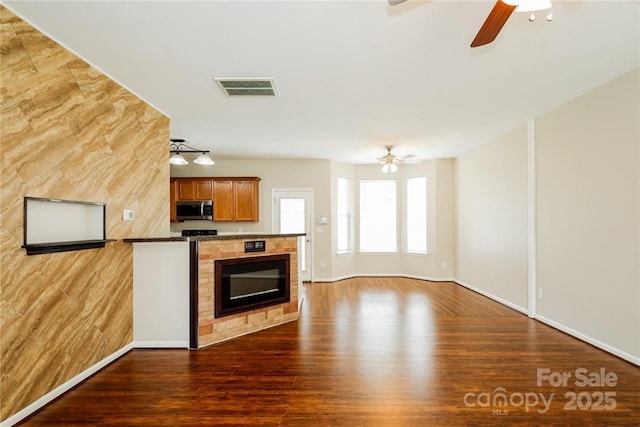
273 190 313 282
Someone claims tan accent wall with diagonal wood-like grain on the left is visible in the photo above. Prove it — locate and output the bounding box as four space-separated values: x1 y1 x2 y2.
0 6 169 420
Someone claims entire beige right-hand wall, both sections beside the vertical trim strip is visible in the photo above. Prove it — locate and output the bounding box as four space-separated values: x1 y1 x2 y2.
456 69 640 364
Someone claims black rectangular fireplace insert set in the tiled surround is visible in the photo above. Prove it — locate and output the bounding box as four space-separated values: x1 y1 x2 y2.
214 254 290 318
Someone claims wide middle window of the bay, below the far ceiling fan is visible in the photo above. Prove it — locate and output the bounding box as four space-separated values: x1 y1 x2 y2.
360 180 397 252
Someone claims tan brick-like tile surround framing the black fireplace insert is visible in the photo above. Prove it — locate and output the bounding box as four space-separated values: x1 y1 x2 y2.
197 236 298 348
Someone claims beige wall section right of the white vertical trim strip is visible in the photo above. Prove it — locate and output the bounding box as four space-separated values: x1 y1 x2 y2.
536 69 640 360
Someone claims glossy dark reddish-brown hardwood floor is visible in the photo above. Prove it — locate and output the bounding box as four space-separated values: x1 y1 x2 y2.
18 278 640 426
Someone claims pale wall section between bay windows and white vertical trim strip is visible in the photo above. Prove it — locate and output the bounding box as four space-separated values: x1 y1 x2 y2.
455 125 528 310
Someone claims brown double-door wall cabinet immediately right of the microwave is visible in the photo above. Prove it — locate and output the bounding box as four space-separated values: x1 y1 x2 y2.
213 178 260 222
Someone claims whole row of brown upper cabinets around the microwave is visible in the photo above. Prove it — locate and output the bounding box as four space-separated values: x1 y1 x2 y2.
170 177 260 222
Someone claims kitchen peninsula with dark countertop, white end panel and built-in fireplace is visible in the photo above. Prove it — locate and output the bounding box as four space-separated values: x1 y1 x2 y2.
124 234 304 349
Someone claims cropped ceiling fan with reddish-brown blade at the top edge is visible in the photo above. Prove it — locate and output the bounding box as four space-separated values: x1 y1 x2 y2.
387 0 553 47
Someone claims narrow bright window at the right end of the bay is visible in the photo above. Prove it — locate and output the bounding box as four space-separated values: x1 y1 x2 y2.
407 177 427 254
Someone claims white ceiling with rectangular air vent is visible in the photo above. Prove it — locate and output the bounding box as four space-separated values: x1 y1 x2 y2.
4 0 640 163
